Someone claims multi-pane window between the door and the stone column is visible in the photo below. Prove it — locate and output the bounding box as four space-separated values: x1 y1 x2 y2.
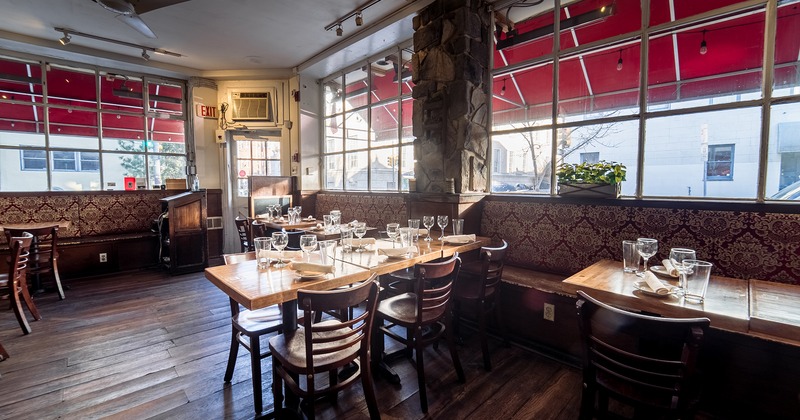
323 43 414 191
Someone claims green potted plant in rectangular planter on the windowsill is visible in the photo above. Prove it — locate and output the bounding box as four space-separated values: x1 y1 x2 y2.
556 161 626 198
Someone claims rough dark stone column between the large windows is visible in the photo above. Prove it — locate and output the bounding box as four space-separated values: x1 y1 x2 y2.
412 0 491 194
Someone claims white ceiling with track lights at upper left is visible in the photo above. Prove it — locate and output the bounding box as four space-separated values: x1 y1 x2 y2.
0 0 431 79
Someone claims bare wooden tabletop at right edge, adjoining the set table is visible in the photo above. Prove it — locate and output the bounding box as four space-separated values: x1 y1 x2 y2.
750 280 800 345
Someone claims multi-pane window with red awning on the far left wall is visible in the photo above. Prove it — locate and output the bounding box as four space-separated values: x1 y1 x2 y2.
0 57 186 191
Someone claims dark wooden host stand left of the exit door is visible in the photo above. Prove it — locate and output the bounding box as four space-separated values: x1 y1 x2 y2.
159 191 208 275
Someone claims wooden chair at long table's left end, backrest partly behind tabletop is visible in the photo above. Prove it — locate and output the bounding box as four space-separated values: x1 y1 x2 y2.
222 251 283 413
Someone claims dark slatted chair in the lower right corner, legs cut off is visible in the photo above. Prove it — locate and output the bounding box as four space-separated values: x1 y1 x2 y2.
577 291 710 419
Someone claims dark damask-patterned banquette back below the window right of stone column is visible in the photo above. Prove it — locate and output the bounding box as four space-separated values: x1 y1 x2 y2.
481 200 800 284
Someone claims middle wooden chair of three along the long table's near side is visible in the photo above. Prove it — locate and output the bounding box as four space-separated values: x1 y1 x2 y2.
372 253 465 413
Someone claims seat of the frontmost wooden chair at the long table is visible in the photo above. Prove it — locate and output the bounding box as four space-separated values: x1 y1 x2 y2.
269 319 359 370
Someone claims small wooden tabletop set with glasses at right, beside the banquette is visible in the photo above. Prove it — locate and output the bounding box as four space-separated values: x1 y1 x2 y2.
563 260 750 333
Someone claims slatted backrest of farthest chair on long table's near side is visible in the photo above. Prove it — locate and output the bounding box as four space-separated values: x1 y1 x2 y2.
414 252 461 325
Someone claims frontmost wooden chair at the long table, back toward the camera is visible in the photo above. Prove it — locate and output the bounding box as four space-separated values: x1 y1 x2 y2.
269 274 380 419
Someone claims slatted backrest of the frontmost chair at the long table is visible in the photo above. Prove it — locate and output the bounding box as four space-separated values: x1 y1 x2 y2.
297 274 379 372
